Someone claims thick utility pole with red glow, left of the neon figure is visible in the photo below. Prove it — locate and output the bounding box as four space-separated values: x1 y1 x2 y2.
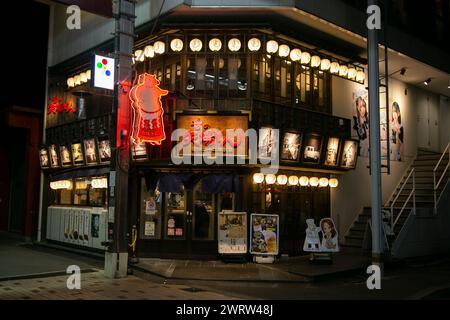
105 0 136 278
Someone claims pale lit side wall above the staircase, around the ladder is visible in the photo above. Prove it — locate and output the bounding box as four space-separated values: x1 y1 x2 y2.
331 77 440 239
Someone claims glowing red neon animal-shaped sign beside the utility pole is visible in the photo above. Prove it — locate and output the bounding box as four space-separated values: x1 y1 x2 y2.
130 73 169 145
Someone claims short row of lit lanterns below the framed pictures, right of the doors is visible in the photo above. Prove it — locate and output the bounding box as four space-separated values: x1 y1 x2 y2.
253 173 339 188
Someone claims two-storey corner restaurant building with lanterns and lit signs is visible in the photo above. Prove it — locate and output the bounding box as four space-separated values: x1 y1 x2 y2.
40 1 450 259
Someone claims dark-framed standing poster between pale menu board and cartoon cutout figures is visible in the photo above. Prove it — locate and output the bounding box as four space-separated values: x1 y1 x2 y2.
250 213 279 256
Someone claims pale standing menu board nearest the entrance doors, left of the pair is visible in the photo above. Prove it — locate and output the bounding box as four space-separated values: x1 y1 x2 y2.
218 211 247 254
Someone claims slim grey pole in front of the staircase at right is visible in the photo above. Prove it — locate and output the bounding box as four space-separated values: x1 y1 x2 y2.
367 0 387 274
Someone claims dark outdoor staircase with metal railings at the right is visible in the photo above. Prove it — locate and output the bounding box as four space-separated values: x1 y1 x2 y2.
342 144 450 250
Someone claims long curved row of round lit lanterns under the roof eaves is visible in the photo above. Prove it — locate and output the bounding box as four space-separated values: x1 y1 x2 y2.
133 38 366 83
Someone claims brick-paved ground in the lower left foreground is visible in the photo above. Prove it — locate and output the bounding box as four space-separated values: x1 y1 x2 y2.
0 270 236 300
